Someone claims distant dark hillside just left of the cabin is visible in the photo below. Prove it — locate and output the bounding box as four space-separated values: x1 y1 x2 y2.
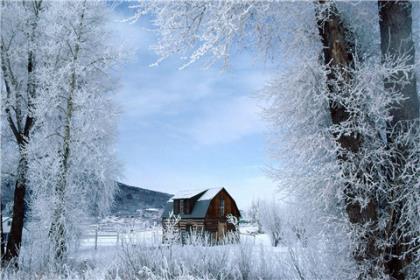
111 183 172 216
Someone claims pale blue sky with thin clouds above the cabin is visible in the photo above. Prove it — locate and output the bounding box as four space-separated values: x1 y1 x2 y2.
113 6 275 208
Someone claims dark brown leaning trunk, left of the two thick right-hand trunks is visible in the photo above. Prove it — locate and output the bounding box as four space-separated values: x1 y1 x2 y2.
317 1 378 276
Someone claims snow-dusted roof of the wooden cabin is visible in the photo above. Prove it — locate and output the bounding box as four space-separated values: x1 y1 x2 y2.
162 188 223 219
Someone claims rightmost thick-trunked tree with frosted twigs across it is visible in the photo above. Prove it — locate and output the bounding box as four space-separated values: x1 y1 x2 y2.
378 1 420 279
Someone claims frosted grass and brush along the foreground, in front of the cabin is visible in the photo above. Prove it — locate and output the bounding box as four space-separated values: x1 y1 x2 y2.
2 223 354 280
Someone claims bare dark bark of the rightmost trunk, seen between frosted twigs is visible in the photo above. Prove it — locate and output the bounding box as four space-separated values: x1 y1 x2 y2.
378 1 420 279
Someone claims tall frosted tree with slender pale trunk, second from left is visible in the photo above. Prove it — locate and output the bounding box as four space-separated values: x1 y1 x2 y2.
24 1 121 265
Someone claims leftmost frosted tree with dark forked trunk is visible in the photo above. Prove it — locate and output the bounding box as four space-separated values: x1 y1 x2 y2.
0 0 45 260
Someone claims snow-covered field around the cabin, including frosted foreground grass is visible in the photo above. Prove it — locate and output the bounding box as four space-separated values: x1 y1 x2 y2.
2 218 343 280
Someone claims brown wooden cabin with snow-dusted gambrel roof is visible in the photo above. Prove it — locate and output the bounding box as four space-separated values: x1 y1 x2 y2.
162 188 240 240
